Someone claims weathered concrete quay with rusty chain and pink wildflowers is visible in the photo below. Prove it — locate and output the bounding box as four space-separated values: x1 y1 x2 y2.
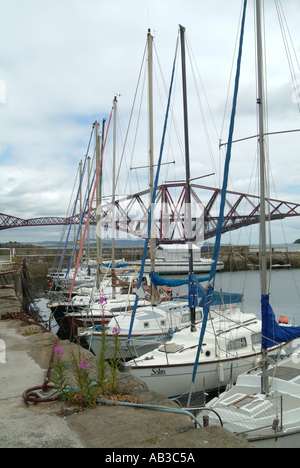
0 288 251 451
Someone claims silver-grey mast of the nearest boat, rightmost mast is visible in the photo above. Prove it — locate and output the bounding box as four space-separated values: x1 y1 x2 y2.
256 0 269 393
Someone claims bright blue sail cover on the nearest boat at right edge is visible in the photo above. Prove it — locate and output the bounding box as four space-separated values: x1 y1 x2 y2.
261 294 300 348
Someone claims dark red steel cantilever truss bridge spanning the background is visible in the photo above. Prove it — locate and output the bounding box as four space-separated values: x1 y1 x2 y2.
0 183 300 243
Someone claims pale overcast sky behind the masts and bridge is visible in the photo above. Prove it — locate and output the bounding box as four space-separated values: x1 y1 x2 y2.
0 0 300 243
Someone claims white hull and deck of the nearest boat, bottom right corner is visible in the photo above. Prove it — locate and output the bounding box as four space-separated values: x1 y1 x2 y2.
206 354 300 448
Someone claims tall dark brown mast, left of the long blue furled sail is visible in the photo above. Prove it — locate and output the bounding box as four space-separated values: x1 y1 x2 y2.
179 25 196 331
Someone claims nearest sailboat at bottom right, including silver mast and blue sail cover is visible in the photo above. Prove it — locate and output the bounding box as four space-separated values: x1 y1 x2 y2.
207 0 300 448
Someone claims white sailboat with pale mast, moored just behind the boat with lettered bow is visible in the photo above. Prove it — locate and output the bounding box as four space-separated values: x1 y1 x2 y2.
82 30 202 359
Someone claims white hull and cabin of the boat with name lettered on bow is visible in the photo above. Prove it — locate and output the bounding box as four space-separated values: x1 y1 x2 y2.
125 308 290 398
